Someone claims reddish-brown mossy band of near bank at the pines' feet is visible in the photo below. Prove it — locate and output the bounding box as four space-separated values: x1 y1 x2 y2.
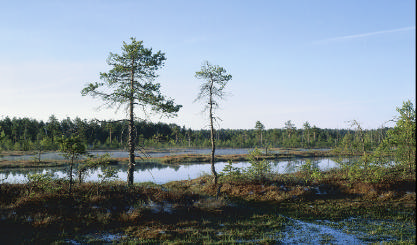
0 168 416 242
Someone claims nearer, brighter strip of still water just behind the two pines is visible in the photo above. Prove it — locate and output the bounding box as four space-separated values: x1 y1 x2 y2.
0 158 339 184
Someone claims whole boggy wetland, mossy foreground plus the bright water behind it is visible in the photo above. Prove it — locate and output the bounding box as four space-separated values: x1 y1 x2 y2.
0 149 416 244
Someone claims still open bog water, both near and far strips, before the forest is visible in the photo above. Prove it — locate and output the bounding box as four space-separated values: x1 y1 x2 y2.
0 149 339 184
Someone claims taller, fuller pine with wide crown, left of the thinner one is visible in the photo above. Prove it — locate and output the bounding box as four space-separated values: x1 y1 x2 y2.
81 38 181 185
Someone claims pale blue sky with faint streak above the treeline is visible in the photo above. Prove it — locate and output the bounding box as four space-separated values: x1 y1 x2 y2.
0 0 416 129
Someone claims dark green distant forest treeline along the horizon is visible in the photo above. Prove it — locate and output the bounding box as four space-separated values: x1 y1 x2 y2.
0 115 389 152
